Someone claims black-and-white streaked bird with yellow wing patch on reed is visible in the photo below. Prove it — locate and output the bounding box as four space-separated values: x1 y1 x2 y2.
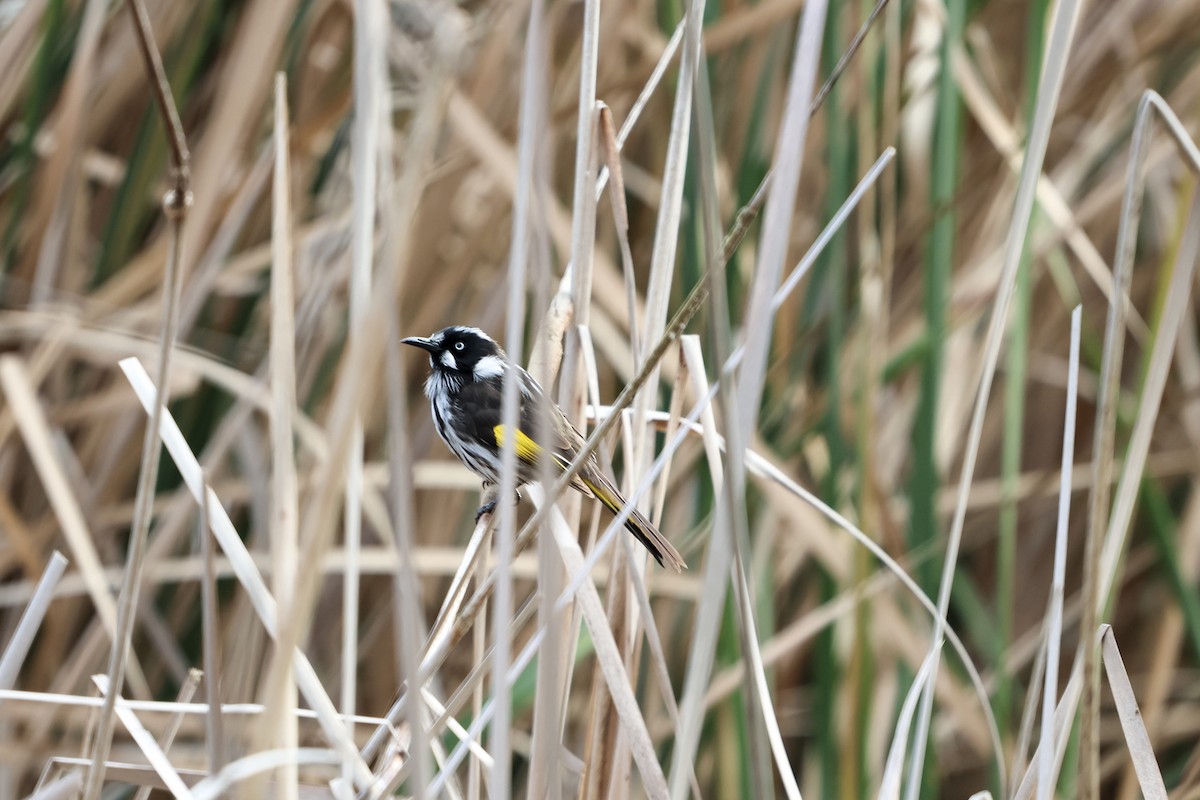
402 325 688 572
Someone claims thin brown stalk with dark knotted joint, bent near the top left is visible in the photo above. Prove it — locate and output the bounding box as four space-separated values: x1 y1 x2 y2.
83 0 192 800
